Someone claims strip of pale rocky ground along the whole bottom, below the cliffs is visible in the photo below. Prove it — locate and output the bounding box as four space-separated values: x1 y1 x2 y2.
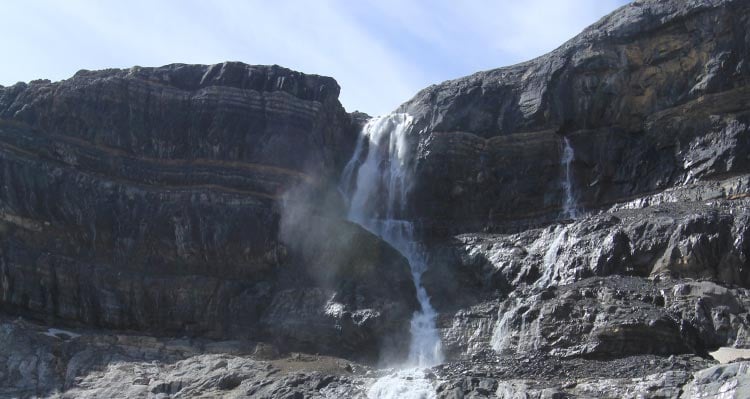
0 319 750 398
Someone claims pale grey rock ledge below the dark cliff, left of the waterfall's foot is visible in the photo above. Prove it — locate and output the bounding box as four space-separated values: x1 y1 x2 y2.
0 320 368 399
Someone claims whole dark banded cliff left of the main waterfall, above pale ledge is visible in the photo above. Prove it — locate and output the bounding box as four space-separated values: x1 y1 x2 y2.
0 63 416 358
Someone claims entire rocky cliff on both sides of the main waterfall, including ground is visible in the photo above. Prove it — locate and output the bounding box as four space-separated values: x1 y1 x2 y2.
0 0 750 398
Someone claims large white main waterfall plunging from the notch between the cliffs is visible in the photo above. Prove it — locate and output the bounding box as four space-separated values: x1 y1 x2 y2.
340 114 443 367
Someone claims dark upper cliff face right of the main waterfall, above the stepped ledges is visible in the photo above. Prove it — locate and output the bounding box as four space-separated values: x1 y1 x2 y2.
399 1 750 233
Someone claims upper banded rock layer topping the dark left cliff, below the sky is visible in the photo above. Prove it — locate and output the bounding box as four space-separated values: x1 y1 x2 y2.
0 63 355 171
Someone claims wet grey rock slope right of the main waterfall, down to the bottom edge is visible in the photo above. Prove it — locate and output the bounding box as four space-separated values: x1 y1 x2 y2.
424 175 750 398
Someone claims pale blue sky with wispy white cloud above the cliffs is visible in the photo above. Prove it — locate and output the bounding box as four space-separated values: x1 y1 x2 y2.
0 0 628 115
